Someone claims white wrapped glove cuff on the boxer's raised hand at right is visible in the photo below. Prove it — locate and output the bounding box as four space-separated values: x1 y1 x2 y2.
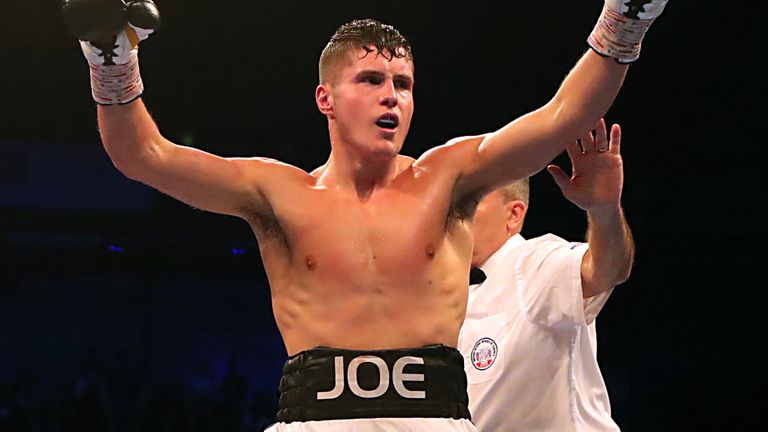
587 0 667 63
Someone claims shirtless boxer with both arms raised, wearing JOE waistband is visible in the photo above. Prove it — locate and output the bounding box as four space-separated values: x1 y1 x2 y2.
64 0 666 431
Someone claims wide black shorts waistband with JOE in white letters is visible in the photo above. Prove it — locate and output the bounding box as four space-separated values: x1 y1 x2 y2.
277 345 470 423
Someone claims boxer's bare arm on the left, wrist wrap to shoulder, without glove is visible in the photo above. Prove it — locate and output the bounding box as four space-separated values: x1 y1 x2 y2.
98 99 286 216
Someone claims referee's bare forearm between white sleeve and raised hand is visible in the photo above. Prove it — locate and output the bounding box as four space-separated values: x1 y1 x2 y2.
581 206 635 298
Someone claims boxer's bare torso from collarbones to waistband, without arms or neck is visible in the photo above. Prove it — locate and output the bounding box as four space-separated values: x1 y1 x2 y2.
255 151 472 353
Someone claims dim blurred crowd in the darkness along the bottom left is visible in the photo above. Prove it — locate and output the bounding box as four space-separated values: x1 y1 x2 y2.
0 362 277 432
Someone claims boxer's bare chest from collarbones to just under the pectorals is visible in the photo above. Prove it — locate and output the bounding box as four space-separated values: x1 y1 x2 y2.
249 167 471 289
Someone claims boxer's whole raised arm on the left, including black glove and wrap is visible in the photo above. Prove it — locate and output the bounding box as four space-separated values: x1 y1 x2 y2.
62 0 288 217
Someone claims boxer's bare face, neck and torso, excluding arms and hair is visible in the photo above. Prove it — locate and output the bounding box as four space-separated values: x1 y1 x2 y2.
246 50 472 353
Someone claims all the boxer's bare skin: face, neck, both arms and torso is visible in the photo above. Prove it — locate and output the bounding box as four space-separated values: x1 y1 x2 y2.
98 49 626 355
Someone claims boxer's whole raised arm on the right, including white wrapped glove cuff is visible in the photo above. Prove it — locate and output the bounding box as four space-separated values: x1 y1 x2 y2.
450 0 666 196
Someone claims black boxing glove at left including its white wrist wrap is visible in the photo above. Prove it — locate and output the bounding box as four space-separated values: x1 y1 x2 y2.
62 0 160 105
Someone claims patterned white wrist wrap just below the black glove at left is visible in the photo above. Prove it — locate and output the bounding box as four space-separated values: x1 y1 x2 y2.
90 54 144 105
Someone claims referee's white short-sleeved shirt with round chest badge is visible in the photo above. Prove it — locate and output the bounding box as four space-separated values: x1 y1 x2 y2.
459 234 619 432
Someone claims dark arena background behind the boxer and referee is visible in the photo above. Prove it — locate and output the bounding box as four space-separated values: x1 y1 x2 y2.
0 0 768 431
